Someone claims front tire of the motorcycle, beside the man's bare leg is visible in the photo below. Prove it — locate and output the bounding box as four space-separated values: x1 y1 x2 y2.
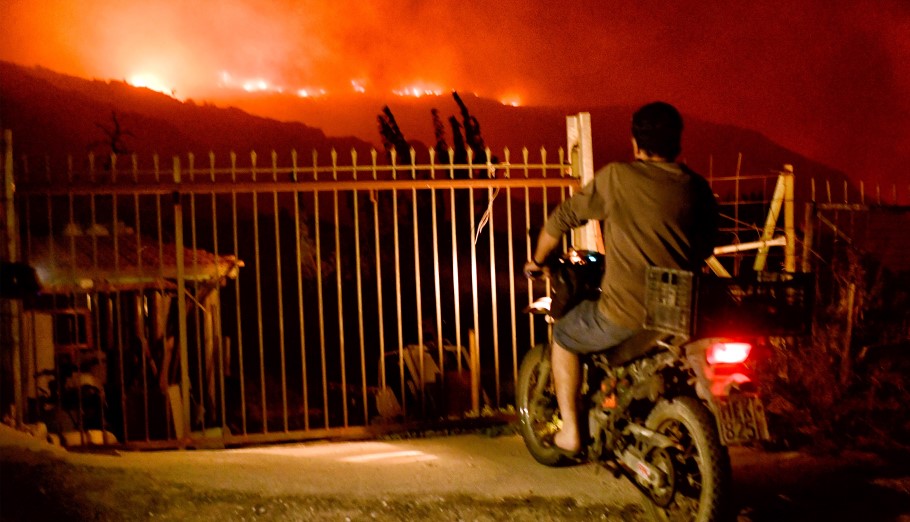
516 344 570 466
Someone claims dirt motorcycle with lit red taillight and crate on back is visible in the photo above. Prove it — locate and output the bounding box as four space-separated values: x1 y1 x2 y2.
517 251 811 521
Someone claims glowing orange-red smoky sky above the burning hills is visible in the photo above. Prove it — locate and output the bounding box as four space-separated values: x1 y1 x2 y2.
0 0 910 182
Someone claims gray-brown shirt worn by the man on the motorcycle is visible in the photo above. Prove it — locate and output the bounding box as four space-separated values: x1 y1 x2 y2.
545 161 717 329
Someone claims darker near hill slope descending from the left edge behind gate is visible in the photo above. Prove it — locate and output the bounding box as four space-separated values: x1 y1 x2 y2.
0 62 369 164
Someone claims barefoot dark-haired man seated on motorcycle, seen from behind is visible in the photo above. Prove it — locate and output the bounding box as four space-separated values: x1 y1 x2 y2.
525 102 717 455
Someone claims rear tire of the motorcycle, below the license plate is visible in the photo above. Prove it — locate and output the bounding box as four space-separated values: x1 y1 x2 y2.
645 397 732 522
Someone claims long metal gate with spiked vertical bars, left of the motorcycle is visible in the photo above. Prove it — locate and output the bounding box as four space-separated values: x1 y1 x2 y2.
8 143 578 448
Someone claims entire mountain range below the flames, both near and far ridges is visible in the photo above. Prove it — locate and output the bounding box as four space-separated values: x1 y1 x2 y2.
0 58 846 199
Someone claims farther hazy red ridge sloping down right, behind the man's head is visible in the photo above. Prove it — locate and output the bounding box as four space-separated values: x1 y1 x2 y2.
217 86 853 199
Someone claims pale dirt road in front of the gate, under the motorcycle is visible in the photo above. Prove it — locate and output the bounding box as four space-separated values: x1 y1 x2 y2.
0 427 910 521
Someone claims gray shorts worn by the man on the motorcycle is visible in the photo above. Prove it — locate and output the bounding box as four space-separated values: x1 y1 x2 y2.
553 300 635 354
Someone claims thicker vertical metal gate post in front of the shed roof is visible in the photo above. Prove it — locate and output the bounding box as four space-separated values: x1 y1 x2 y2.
174 156 190 440
